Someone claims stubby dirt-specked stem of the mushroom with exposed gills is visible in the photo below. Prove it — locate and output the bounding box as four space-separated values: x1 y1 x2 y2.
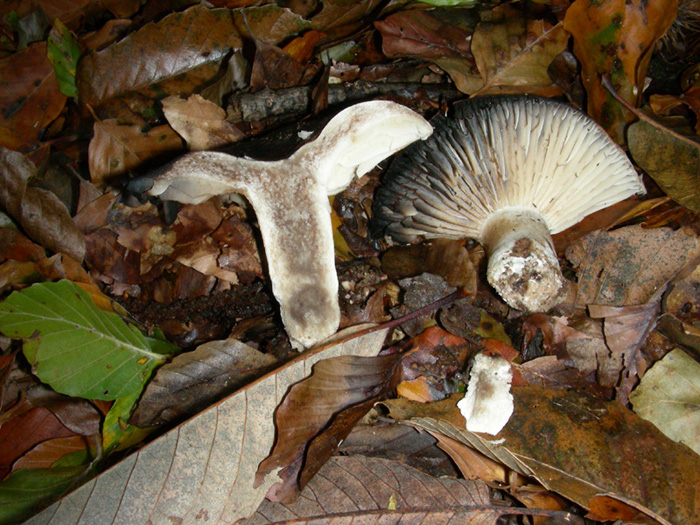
481 207 564 312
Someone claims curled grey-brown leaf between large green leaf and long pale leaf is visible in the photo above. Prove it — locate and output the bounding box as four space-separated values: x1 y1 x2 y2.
129 339 277 427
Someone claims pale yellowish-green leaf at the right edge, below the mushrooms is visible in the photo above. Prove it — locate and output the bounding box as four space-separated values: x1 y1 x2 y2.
630 349 700 454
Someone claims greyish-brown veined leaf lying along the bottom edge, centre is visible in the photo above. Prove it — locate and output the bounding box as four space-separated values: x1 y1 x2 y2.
244 456 500 525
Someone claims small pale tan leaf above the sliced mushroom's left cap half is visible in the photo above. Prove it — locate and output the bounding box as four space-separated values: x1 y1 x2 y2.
161 95 245 151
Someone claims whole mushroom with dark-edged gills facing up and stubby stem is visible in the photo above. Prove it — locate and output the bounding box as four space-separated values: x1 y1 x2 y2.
373 95 645 312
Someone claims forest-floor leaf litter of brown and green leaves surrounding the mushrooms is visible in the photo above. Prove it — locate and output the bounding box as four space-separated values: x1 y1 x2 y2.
0 0 700 523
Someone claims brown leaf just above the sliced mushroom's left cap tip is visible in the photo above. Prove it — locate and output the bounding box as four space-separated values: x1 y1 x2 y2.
88 119 182 184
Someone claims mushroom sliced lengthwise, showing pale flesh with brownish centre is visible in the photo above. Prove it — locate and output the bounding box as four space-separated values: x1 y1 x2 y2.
135 101 432 348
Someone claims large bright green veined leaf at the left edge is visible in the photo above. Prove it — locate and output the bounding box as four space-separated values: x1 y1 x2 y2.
0 280 176 400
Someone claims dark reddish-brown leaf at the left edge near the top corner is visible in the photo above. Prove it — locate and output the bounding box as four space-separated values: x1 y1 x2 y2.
0 42 67 149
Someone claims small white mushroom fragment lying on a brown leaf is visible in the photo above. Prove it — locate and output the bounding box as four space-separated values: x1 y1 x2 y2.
457 354 514 436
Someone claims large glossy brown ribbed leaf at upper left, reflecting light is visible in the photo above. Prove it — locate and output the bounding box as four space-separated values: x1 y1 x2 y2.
77 5 242 107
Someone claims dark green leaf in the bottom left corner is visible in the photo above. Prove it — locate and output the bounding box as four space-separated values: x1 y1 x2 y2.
0 465 86 523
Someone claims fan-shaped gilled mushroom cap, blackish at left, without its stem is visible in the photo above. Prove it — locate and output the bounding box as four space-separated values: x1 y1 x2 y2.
373 95 645 242
